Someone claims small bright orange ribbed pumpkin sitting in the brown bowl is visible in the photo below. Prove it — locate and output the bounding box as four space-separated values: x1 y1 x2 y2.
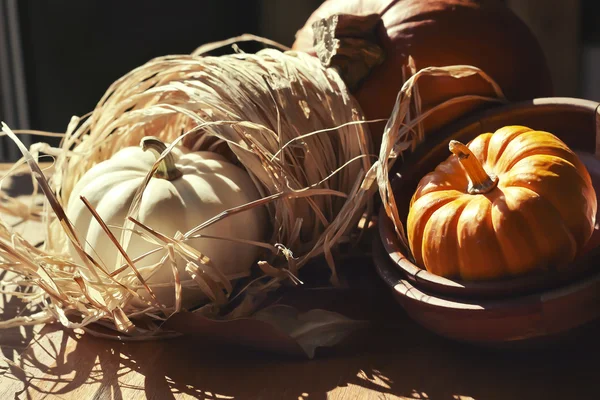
407 126 597 280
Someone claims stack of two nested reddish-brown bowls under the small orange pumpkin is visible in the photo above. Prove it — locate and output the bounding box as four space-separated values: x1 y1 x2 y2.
373 98 600 345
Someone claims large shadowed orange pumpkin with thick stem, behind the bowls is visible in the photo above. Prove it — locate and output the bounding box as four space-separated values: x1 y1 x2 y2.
293 0 553 144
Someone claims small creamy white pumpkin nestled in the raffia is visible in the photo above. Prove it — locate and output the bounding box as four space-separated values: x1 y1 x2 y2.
66 140 266 307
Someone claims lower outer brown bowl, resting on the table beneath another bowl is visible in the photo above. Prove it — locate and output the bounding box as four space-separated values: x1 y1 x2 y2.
373 233 600 347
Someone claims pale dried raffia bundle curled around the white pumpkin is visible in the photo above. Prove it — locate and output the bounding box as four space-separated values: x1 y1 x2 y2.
0 36 376 339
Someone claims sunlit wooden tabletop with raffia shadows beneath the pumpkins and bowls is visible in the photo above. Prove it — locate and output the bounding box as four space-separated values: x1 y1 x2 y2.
0 165 600 400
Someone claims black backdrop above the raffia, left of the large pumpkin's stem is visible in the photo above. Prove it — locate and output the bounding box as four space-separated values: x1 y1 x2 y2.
18 0 320 132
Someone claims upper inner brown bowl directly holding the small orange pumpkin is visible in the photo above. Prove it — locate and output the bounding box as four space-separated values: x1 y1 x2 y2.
379 98 600 299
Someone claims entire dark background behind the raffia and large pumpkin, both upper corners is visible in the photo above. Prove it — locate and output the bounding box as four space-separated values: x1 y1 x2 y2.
0 0 600 161
